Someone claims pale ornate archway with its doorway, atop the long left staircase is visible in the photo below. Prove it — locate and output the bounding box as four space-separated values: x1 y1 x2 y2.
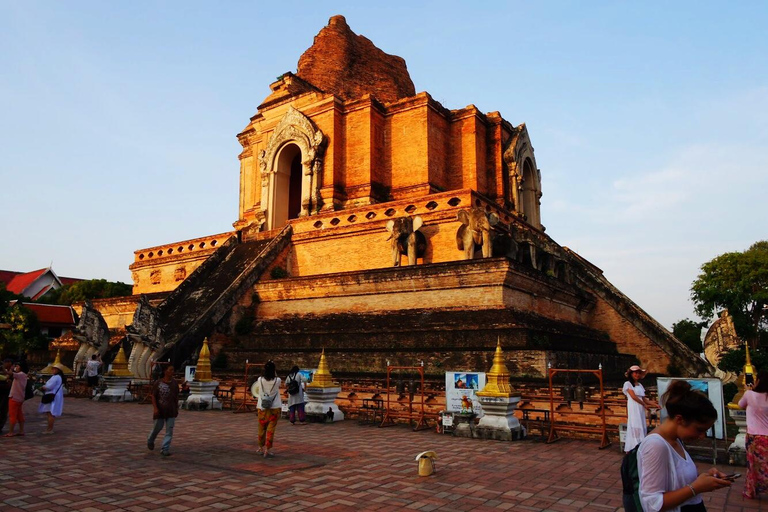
259 106 325 229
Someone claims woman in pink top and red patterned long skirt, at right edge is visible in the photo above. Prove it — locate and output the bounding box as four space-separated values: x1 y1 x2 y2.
739 371 768 499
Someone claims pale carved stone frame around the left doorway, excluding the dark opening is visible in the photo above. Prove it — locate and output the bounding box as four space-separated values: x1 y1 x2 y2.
259 106 325 229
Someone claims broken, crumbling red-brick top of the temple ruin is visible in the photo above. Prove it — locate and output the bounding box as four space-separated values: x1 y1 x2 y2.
296 16 416 103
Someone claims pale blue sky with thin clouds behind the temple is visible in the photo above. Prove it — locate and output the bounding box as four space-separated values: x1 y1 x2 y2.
0 0 768 327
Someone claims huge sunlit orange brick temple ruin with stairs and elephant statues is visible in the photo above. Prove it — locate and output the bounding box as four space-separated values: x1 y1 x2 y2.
81 16 712 378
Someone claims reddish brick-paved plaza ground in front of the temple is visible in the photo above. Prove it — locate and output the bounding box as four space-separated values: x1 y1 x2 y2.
0 398 768 512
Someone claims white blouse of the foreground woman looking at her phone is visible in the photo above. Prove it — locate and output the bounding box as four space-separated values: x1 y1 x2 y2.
637 434 702 512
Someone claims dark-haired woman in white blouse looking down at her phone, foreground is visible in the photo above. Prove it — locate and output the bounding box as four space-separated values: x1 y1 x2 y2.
637 380 731 512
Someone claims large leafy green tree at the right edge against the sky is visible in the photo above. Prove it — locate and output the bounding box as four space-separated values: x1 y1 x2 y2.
691 240 768 347
